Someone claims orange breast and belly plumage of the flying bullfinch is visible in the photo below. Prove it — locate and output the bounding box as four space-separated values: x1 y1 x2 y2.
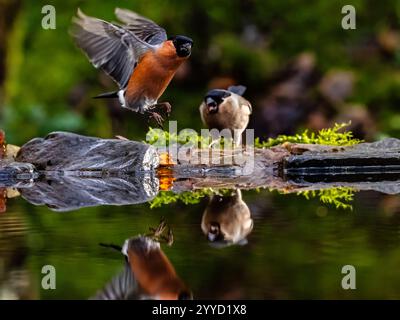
126 41 185 100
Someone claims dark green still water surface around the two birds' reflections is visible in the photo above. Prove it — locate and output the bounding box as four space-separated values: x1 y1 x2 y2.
0 191 400 299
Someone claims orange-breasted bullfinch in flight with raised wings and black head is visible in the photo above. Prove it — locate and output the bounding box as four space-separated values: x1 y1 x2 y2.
71 8 193 125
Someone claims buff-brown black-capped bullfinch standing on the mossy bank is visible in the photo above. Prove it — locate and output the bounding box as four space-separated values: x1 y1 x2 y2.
200 86 252 147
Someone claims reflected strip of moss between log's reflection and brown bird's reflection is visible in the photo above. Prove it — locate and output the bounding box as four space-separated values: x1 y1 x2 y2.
150 188 232 208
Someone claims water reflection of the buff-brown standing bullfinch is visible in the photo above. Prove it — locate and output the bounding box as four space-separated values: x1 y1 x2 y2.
201 189 253 247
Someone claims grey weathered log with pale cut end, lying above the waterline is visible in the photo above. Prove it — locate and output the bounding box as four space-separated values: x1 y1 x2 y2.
16 132 159 172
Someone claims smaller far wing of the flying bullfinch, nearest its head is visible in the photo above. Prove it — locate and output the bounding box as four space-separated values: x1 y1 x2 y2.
115 8 167 45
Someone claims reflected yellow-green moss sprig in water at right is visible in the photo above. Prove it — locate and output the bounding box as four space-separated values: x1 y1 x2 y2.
297 187 354 210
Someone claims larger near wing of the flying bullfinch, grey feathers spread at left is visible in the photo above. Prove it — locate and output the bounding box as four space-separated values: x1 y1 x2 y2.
71 9 155 89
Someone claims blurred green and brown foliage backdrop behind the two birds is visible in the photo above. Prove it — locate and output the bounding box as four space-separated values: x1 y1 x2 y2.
0 0 400 144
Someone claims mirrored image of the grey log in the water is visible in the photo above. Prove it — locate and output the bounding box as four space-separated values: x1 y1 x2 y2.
20 172 159 211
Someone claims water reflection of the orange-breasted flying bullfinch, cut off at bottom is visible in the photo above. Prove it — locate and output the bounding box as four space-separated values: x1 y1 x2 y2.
94 220 192 300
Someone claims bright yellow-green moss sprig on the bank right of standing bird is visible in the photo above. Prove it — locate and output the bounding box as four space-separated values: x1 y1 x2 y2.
255 122 362 148
